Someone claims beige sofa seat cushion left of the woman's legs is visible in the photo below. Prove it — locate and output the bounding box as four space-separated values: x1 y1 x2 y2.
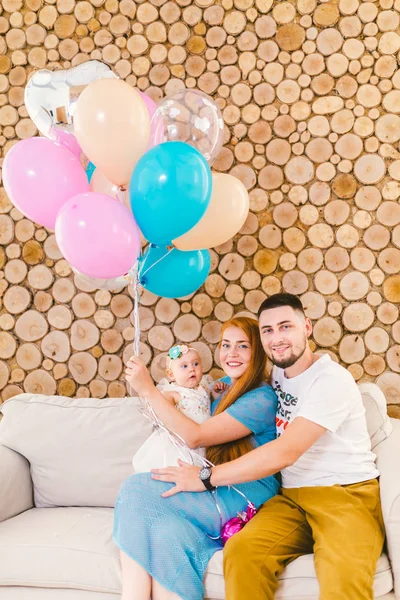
0 507 121 597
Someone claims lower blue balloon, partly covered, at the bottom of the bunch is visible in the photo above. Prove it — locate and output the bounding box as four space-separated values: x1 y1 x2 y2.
139 244 211 298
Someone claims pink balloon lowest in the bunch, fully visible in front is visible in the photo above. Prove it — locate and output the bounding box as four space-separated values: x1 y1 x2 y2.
56 192 140 279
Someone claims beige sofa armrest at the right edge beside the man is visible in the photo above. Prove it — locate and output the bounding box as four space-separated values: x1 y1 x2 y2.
374 419 400 598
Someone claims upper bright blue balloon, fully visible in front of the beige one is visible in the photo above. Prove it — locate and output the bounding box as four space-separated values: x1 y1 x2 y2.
129 142 212 246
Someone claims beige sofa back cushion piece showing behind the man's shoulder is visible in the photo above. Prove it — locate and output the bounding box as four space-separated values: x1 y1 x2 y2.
358 381 392 449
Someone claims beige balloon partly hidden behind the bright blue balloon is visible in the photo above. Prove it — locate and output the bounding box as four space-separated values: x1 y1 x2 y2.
173 173 249 250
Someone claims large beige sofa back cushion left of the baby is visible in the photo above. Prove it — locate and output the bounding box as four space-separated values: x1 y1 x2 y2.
0 394 151 508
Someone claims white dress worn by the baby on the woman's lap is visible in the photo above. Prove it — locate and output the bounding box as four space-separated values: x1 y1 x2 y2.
132 375 214 473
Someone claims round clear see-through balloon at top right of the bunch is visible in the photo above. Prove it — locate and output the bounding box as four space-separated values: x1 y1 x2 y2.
151 89 224 165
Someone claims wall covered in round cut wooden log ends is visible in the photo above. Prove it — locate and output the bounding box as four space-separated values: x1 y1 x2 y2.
0 0 400 415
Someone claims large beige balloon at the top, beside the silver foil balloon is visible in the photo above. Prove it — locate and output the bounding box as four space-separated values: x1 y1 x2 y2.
74 79 150 186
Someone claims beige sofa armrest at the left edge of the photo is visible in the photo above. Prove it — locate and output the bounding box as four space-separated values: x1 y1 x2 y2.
0 444 33 523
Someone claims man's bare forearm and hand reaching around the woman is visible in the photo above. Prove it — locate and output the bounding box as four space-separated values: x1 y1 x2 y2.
152 417 327 498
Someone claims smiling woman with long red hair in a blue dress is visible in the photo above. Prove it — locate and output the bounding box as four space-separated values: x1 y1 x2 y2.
113 317 279 600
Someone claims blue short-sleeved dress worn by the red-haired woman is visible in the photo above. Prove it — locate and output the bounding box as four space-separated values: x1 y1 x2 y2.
113 378 279 600
